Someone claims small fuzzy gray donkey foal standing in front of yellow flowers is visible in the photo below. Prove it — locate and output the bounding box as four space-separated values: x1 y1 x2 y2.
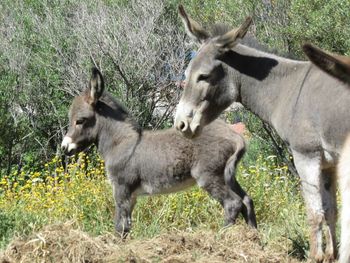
62 68 257 234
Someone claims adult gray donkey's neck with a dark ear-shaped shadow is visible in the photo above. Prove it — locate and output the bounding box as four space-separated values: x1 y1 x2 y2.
227 44 310 123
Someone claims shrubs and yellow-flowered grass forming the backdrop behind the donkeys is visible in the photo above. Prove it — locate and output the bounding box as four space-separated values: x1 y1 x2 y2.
0 0 350 258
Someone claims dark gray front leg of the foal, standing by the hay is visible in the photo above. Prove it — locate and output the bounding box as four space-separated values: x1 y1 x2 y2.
113 182 136 237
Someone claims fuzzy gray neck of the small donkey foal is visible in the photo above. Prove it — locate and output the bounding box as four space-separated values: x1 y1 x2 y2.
96 104 141 163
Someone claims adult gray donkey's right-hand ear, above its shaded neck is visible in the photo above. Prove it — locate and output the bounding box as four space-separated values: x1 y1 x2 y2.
216 16 253 50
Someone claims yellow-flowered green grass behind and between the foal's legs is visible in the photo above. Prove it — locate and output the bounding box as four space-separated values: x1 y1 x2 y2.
0 154 308 259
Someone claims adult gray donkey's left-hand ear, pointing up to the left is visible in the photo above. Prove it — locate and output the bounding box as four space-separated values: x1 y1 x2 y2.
179 5 210 43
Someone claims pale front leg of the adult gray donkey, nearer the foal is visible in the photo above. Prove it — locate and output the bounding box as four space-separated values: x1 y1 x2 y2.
293 152 325 262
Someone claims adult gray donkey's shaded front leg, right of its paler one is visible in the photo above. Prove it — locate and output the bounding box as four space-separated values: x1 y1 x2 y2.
322 168 337 261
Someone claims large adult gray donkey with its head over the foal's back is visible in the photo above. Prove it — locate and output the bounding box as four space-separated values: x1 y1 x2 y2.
175 6 350 262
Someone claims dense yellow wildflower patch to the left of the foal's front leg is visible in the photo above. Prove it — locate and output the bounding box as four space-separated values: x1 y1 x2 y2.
0 153 110 227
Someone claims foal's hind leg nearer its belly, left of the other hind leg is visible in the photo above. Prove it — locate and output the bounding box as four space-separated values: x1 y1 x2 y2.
197 174 243 226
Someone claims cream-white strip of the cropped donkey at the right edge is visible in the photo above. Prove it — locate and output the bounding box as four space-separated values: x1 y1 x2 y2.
338 136 350 263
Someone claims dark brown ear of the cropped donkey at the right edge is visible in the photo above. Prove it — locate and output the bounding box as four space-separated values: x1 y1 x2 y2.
303 44 350 85
